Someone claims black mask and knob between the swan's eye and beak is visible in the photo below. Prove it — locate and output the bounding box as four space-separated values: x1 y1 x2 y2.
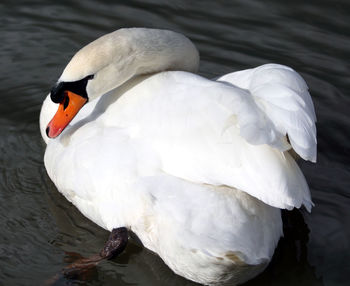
50 75 94 104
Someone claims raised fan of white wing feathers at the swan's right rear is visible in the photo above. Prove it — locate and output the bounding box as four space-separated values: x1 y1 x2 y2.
219 64 316 162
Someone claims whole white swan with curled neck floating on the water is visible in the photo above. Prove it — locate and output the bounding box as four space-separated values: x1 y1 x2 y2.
40 28 316 285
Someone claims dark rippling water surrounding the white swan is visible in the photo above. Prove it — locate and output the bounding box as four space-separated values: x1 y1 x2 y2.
0 0 350 286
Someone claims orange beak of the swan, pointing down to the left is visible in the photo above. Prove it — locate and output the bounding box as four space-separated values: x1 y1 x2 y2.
46 91 87 138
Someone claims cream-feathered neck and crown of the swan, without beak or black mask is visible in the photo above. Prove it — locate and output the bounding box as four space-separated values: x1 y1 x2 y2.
60 28 199 99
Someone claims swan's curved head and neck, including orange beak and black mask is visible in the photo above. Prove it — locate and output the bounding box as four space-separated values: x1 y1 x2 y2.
46 28 199 138
